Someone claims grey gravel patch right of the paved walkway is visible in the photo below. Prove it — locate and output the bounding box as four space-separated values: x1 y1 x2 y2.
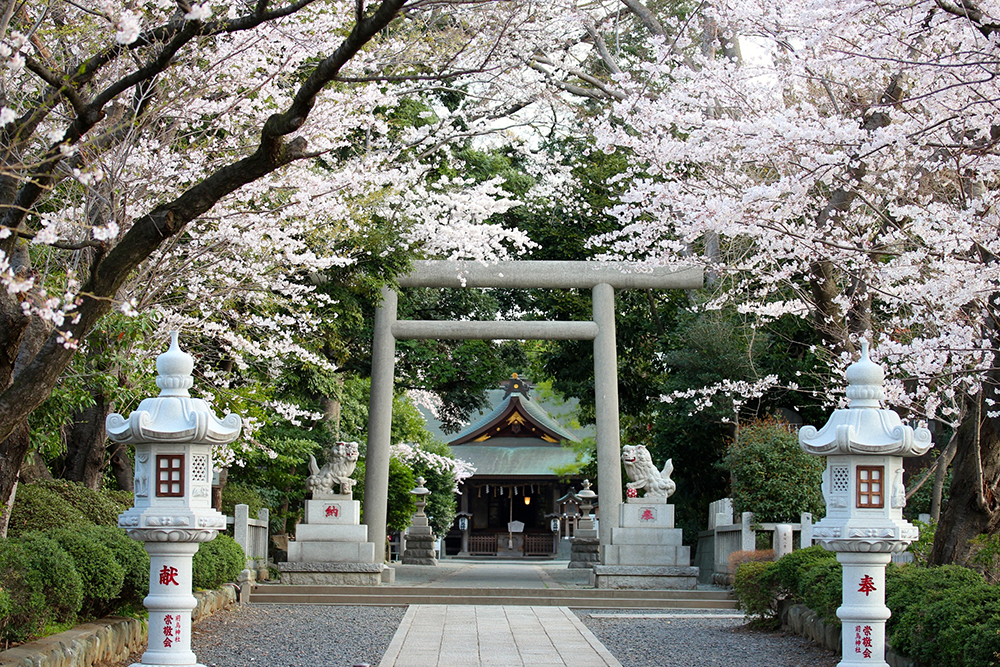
575 609 839 667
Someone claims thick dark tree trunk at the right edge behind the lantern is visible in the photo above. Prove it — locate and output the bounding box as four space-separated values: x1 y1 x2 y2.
929 391 1000 565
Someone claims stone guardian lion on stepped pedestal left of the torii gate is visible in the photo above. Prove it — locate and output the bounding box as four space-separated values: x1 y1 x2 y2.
278 442 392 586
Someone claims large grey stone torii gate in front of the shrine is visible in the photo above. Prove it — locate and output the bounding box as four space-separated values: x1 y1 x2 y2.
364 260 703 560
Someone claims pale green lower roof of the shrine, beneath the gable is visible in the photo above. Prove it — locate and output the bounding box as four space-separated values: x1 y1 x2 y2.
452 438 576 479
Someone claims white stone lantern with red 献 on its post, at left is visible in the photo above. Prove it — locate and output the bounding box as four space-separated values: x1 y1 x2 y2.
107 331 242 667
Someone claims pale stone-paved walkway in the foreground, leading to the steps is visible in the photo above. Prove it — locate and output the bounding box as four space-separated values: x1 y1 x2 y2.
379 605 622 667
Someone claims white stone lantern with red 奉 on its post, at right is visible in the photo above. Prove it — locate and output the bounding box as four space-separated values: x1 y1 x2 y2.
799 342 933 667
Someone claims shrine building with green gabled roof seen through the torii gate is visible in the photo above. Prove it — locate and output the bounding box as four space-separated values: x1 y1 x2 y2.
445 373 582 558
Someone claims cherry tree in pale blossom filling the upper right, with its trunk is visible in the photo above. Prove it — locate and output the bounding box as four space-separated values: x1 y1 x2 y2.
592 0 1000 563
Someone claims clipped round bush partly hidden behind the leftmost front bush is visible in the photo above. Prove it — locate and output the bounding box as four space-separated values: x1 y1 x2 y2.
45 528 125 617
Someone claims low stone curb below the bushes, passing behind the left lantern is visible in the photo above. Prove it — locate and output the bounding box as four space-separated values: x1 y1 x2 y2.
0 585 236 667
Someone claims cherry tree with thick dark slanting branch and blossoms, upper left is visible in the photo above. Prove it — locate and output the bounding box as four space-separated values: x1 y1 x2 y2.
0 0 581 532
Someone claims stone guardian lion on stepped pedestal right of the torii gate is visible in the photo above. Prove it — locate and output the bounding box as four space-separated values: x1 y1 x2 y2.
591 445 698 590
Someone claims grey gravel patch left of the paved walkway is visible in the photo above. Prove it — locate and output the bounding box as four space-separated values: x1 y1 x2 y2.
191 605 406 667
